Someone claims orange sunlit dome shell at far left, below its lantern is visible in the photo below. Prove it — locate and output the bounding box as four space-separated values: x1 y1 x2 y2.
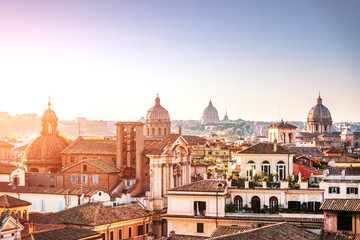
24 135 69 160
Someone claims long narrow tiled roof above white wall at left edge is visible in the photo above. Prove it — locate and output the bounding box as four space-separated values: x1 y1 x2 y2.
0 186 100 197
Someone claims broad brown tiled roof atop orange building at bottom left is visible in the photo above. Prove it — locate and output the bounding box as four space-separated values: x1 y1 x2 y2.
54 203 150 226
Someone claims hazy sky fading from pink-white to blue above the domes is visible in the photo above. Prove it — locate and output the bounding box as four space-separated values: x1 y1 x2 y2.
0 0 360 122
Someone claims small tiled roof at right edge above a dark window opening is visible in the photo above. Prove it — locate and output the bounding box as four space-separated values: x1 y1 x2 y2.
320 199 360 212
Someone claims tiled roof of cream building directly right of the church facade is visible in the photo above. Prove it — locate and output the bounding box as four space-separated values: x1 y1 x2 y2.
169 179 226 192
